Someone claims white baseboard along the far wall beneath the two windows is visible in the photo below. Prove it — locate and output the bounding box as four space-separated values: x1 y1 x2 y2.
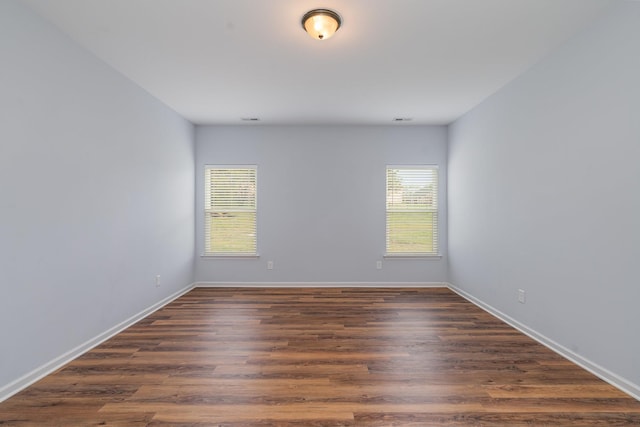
195 282 448 288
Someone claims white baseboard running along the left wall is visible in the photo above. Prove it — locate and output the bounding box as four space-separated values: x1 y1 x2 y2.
0 283 194 402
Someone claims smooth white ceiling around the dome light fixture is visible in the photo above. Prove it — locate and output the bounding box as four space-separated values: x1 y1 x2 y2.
24 0 615 124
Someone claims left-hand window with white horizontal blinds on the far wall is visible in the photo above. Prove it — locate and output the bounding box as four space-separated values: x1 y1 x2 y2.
204 166 257 256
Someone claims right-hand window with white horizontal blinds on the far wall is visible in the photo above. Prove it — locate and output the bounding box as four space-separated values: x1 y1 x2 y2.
386 166 439 256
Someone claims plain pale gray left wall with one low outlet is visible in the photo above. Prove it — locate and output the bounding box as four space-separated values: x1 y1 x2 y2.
0 0 194 394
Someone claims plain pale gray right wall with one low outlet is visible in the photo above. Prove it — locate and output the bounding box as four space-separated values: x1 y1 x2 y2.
449 2 640 395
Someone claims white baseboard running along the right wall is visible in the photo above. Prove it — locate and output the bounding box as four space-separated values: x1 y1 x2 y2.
447 283 640 400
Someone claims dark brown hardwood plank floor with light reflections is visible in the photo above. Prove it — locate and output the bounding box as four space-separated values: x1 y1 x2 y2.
0 288 640 426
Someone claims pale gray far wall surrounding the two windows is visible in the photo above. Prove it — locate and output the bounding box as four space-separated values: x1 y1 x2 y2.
196 126 447 283
